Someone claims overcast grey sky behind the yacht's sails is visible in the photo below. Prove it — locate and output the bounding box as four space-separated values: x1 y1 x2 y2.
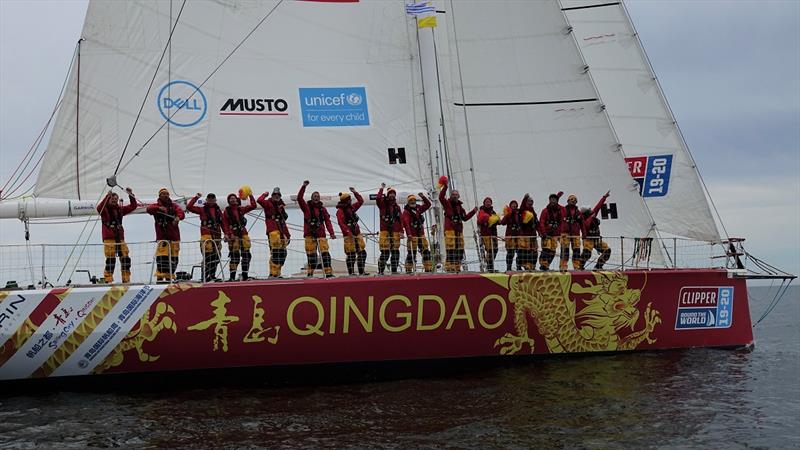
0 0 800 281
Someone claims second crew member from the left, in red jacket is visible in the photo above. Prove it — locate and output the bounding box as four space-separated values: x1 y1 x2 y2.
147 188 185 282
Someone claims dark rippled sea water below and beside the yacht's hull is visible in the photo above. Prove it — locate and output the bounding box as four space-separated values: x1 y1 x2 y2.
0 290 800 448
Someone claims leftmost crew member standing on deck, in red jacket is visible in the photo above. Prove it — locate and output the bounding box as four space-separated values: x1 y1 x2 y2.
97 187 137 283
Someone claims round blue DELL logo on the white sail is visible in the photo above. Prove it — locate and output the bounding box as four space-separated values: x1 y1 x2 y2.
158 80 208 127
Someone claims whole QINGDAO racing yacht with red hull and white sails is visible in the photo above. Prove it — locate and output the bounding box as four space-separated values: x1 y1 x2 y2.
0 0 793 379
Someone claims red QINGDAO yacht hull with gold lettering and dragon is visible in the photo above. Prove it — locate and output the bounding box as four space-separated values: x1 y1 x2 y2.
0 270 753 379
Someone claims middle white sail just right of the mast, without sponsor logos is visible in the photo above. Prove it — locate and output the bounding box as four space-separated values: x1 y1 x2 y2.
439 0 655 244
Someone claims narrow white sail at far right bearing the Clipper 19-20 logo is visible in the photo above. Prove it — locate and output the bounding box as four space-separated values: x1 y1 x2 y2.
562 0 720 242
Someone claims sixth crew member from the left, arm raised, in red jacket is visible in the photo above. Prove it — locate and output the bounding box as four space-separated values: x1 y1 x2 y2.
297 180 336 278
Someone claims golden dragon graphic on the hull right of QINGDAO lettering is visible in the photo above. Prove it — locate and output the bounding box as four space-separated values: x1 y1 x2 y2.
491 272 661 355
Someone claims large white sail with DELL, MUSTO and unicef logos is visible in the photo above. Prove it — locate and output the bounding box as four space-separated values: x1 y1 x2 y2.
35 0 430 200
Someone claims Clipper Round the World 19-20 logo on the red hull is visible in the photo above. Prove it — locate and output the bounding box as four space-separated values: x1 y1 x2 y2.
675 286 733 330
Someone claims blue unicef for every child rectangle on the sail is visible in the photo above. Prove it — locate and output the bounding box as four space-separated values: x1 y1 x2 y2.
300 87 369 127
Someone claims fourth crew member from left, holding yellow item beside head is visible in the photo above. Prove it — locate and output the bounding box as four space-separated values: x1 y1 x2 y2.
222 188 256 281
